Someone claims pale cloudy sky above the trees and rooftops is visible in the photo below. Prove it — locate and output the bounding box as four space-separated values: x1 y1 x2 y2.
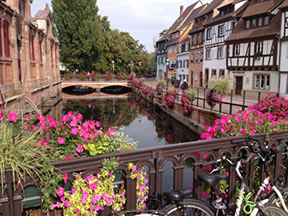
32 0 208 52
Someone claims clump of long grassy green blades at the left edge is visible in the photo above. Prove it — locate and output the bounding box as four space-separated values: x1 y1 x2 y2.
0 119 46 191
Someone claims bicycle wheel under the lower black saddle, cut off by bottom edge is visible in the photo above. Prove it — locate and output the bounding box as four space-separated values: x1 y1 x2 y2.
163 199 215 216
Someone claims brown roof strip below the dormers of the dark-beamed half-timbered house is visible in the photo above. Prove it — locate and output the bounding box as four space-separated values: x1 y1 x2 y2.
226 4 281 42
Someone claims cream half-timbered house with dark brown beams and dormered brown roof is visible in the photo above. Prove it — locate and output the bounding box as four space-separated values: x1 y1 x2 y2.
225 0 283 97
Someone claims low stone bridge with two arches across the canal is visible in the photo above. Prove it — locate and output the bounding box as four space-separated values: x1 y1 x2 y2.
62 80 131 92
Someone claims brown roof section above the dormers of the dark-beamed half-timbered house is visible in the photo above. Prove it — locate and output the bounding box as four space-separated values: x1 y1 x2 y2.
242 0 283 18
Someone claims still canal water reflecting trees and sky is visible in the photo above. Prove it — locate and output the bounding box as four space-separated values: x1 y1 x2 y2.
62 92 199 191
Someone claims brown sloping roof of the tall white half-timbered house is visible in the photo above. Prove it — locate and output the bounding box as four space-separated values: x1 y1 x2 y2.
205 0 250 27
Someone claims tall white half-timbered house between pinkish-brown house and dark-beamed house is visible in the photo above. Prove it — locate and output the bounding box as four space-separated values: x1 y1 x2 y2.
203 0 248 87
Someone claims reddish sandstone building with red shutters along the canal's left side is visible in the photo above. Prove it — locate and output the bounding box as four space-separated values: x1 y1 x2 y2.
0 0 61 108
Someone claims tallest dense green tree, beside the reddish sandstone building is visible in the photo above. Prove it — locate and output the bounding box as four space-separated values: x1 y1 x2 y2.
52 0 103 71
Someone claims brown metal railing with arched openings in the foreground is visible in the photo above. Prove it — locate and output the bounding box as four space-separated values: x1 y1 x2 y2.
0 130 288 216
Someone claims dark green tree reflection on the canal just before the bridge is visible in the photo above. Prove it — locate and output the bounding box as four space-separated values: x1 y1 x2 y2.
62 100 137 130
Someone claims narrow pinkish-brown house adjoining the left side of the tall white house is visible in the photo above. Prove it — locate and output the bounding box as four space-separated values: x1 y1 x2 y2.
188 0 222 87
